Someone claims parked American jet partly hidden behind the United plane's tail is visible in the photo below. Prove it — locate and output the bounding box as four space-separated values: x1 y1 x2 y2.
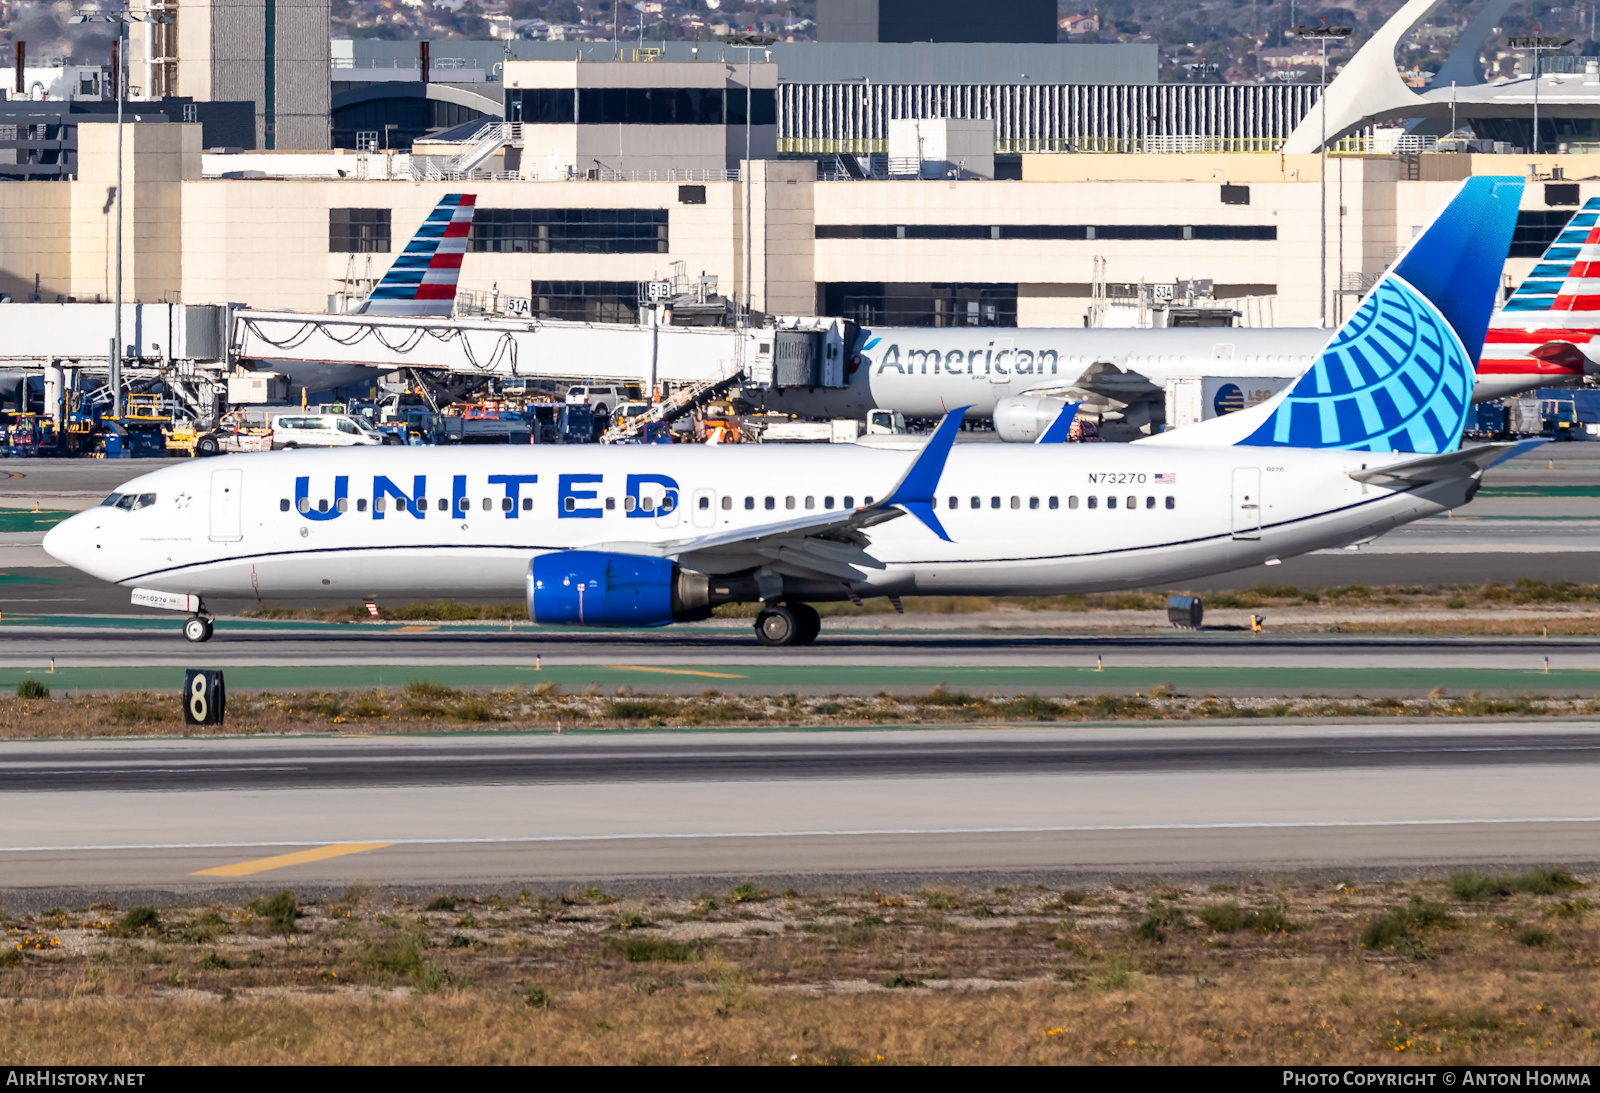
750 198 1600 440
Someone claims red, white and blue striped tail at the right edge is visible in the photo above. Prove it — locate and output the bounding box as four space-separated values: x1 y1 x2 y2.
1478 197 1600 397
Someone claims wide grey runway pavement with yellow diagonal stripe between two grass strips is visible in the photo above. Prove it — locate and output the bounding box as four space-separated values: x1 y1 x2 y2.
0 722 1600 893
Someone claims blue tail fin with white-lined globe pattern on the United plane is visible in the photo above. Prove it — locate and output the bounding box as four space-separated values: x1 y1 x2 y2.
1136 176 1516 454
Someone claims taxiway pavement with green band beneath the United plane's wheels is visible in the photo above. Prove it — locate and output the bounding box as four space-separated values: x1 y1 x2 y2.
0 619 1600 695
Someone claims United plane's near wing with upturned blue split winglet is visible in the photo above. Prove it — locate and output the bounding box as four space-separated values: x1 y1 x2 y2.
586 406 966 581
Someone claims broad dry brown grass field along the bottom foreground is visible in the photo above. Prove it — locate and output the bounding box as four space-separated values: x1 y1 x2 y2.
0 871 1600 1066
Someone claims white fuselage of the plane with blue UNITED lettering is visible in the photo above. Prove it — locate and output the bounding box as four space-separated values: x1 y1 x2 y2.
45 443 1472 602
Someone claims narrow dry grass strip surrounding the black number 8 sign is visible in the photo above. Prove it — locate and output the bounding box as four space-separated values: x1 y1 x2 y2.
9 683 1600 739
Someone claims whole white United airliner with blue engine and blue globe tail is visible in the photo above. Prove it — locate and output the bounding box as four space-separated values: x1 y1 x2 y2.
45 178 1522 645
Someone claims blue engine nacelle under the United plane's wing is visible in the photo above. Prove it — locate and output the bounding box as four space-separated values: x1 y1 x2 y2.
528 551 782 626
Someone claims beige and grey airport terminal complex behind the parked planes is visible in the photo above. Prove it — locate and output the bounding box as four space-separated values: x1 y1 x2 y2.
0 0 1600 326
